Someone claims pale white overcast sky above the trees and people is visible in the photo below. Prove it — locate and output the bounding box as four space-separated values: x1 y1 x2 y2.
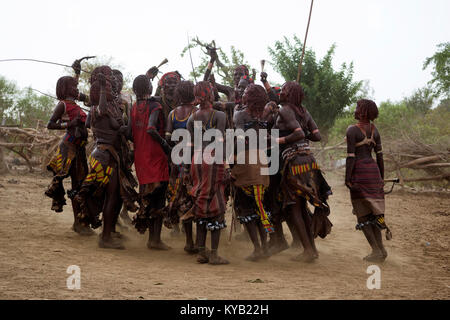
0 0 450 103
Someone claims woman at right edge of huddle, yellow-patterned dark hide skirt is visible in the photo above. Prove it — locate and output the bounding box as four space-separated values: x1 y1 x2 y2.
274 81 332 263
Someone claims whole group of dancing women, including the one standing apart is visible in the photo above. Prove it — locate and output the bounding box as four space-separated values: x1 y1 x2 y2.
45 55 387 265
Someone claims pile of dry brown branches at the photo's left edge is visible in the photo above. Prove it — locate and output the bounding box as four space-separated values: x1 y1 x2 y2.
0 121 64 172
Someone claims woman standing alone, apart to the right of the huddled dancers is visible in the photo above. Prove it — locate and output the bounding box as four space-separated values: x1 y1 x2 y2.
345 99 391 262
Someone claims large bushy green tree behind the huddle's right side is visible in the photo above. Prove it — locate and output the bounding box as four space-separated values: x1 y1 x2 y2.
269 36 367 143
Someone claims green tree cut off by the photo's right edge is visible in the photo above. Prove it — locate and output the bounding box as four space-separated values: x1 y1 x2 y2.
423 42 450 98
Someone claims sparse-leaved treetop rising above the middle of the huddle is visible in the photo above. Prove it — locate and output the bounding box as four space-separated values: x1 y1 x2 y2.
181 37 252 87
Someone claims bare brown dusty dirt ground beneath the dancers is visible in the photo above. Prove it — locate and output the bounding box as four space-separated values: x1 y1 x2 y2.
0 173 450 300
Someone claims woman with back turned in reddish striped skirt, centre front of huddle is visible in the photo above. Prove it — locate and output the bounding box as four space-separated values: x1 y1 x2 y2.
187 81 230 265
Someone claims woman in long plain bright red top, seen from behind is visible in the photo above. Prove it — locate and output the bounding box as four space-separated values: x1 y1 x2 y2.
128 75 171 250
